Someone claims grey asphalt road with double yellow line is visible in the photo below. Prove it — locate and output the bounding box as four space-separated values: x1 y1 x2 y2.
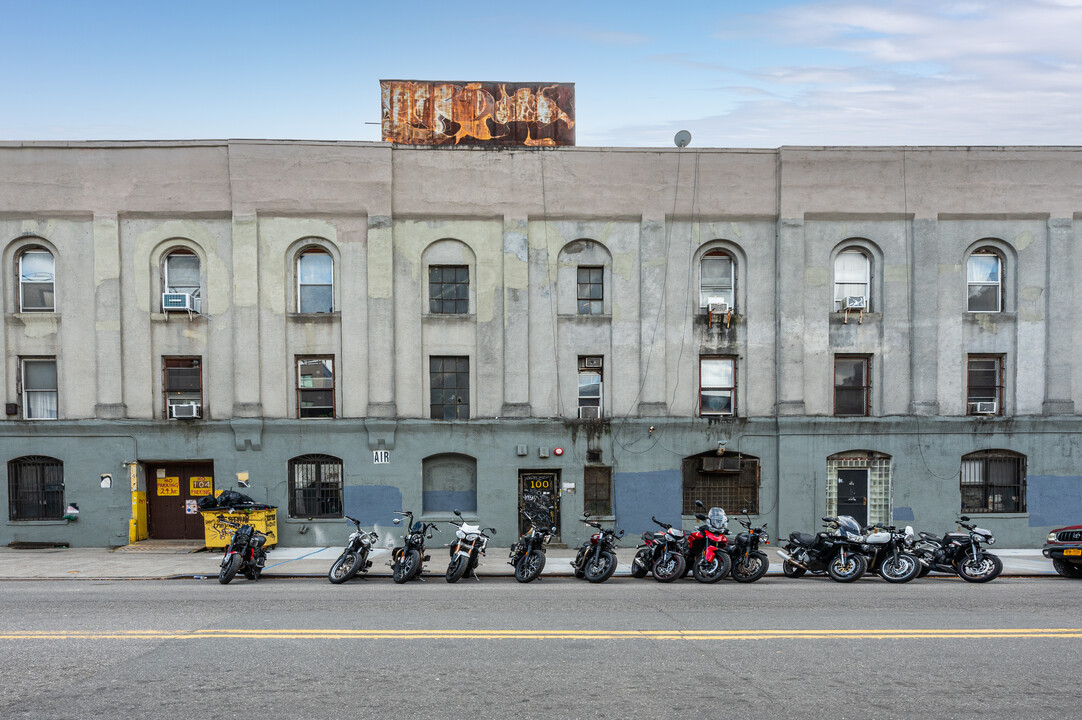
0 577 1082 720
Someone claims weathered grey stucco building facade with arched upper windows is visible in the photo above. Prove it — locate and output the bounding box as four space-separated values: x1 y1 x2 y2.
0 141 1082 547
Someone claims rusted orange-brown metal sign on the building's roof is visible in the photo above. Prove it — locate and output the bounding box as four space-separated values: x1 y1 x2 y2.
380 80 575 146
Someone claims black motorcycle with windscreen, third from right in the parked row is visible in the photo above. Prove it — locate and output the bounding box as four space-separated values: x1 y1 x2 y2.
778 515 868 582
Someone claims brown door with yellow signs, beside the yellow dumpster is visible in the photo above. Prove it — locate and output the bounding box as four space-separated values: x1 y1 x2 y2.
146 461 214 540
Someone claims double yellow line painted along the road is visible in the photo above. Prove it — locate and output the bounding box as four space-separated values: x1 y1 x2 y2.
0 628 1082 641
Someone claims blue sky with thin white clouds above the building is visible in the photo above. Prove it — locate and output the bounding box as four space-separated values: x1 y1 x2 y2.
0 0 1082 147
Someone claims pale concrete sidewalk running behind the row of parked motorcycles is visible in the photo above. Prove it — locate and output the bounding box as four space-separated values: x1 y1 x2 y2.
0 540 1056 580
